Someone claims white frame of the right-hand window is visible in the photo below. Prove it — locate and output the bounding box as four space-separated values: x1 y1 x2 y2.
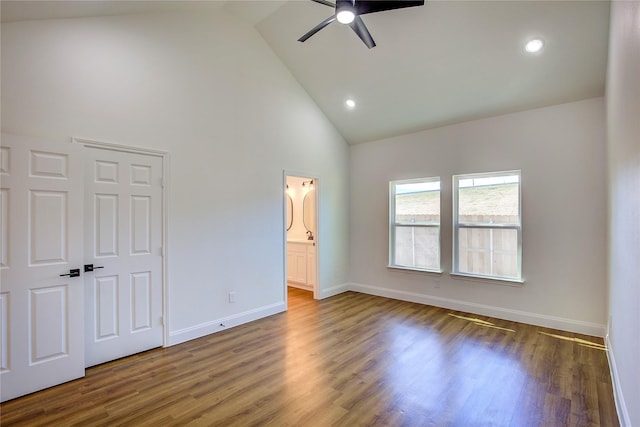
451 170 524 283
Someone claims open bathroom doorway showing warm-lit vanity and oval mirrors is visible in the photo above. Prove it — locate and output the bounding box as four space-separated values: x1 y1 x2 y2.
284 172 319 299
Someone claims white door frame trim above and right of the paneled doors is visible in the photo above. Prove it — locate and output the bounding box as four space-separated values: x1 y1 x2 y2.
71 137 169 347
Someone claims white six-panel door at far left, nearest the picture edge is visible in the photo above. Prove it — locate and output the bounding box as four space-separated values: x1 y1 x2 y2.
0 134 84 401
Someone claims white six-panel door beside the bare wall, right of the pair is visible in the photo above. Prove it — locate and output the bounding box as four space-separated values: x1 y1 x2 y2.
84 148 163 367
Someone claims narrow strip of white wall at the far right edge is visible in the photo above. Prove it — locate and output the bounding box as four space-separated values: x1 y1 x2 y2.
607 1 640 427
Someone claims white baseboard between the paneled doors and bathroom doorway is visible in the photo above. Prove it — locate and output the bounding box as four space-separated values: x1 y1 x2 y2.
167 301 287 347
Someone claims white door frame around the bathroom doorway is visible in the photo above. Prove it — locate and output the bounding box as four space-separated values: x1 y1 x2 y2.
282 169 322 308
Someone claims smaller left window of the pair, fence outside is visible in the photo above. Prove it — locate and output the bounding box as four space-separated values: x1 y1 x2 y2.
389 178 440 272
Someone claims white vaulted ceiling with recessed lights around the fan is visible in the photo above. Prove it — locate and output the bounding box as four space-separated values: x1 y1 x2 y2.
1 0 609 144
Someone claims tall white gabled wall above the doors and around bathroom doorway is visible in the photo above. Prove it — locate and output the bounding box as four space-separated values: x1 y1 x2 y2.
1 10 348 343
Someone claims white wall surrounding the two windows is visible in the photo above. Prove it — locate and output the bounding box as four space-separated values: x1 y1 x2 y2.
350 98 606 336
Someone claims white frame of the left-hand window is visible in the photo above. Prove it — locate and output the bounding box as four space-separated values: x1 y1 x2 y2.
387 177 442 273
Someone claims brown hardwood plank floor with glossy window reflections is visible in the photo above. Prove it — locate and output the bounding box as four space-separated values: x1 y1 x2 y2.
0 288 618 427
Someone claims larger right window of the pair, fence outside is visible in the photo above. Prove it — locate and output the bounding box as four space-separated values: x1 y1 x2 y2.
453 171 522 281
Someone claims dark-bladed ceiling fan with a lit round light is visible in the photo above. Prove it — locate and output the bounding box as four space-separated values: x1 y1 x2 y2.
298 0 424 49
